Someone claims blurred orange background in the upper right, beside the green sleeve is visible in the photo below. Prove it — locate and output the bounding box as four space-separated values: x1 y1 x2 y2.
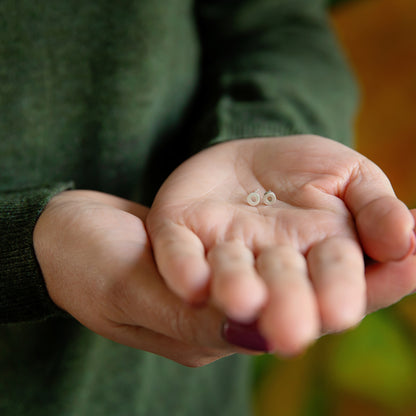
332 0 416 204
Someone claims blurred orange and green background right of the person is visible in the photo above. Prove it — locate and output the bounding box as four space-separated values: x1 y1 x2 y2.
254 0 416 416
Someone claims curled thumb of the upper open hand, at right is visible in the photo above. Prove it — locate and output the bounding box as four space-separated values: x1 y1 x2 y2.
344 159 416 261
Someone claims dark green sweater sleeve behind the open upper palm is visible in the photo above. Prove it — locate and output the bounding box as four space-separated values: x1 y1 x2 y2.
194 0 357 148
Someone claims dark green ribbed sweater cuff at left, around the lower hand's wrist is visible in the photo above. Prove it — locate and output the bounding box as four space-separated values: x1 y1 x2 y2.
0 183 72 324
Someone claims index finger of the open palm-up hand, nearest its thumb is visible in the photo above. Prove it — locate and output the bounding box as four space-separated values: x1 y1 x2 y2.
307 237 366 332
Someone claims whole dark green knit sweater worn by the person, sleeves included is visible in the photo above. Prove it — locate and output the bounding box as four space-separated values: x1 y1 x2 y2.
0 0 355 416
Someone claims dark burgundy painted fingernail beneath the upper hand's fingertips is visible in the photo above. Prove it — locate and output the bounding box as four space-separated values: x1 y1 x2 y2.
222 319 270 352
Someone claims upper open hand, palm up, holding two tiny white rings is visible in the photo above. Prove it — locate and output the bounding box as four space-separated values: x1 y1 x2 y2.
147 136 416 354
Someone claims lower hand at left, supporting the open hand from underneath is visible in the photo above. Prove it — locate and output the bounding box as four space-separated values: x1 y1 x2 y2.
34 191 235 366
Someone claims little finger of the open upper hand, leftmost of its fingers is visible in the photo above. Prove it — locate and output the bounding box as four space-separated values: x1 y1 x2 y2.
150 223 210 303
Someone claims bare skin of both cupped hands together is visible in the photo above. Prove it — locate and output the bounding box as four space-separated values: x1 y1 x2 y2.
34 136 416 360
